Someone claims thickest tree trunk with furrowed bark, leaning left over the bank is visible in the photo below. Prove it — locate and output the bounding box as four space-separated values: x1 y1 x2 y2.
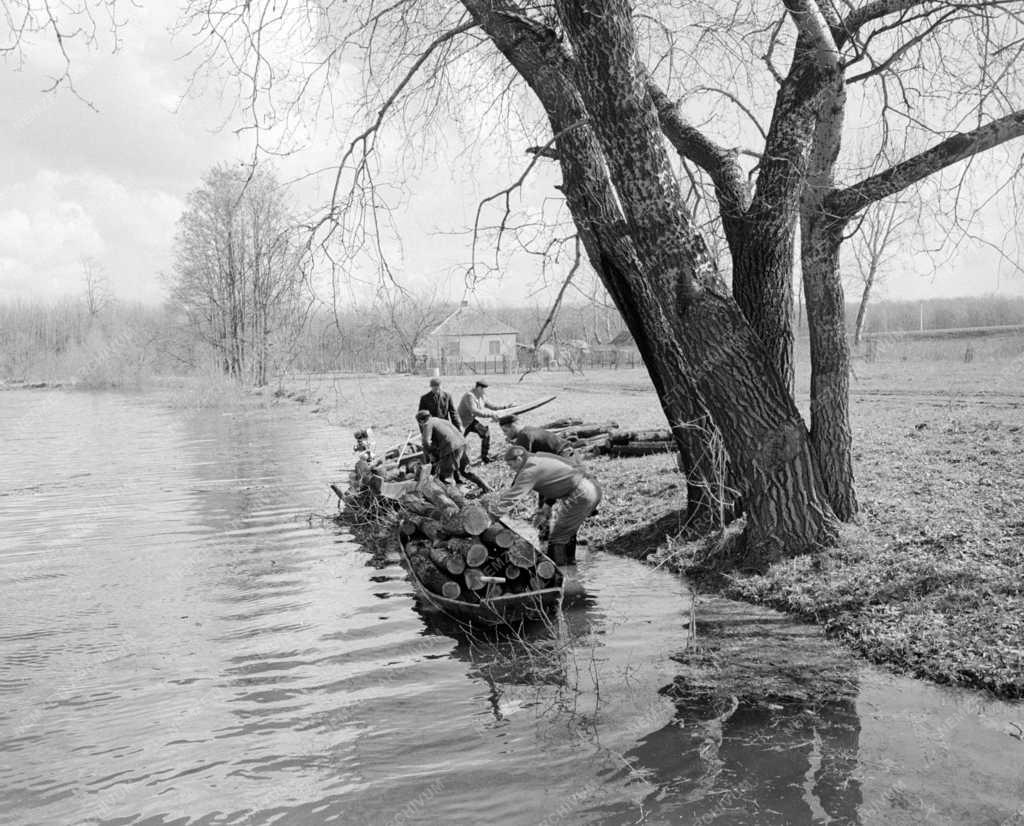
464 0 838 568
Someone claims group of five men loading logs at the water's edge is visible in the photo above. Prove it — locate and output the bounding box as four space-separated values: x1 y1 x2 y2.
416 377 601 565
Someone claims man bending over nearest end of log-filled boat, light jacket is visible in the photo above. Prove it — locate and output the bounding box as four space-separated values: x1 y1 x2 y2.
489 444 601 565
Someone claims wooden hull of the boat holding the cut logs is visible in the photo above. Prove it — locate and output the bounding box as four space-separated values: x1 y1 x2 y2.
398 522 564 627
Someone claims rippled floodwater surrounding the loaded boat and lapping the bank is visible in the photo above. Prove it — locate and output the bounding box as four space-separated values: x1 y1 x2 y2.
0 391 1024 826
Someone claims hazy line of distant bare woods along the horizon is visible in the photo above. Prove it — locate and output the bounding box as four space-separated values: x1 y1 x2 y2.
0 297 1024 387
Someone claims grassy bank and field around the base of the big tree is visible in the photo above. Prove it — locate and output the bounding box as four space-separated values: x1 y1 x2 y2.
298 359 1024 697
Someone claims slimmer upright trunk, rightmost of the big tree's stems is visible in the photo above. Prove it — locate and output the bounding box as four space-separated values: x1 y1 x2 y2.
801 79 857 521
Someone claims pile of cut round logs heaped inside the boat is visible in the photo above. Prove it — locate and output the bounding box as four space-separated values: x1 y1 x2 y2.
398 479 559 602
